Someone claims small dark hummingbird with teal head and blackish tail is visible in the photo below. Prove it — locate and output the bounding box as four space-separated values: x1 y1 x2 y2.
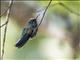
15 17 38 48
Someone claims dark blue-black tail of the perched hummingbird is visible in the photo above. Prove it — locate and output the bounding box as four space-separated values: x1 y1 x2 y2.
15 34 30 48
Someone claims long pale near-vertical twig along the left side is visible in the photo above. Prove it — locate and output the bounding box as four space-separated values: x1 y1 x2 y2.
2 0 13 60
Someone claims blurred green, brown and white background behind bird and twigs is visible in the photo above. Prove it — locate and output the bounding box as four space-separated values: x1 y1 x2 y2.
0 0 80 60
